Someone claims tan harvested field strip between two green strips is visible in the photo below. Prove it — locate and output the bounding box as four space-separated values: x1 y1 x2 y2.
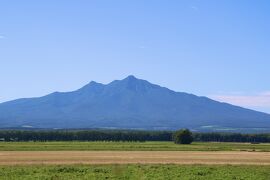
0 151 270 165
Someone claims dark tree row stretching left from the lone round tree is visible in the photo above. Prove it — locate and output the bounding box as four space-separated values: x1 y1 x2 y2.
0 130 172 141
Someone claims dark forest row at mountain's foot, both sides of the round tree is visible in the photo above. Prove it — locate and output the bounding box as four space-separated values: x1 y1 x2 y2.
0 130 270 143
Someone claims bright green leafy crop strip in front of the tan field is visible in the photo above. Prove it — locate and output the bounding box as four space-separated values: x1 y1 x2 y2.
0 165 270 180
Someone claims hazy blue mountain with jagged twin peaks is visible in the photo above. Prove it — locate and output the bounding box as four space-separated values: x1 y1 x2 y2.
0 76 270 130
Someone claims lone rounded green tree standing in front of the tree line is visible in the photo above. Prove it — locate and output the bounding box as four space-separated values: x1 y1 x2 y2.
173 129 193 144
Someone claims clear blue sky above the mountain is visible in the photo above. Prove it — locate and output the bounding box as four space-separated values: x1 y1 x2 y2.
0 0 270 113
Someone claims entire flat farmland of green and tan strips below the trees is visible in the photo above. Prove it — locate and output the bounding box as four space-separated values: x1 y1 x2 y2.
0 141 270 180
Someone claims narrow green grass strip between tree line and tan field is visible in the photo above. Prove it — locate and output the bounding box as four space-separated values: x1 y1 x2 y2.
0 141 270 152
